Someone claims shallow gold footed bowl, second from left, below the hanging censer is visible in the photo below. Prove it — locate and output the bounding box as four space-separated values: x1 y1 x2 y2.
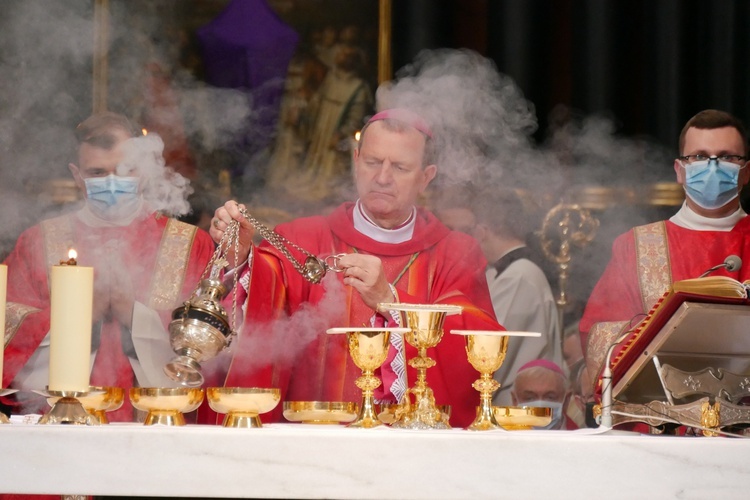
130 387 203 425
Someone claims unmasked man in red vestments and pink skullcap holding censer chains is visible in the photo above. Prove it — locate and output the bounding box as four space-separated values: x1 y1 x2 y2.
210 108 502 427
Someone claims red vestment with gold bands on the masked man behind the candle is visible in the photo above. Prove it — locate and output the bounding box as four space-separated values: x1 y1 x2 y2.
3 211 214 421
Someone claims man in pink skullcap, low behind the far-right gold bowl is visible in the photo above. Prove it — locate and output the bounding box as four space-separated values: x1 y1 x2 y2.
511 359 578 430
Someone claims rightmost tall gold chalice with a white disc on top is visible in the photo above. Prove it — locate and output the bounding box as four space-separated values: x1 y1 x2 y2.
451 330 540 431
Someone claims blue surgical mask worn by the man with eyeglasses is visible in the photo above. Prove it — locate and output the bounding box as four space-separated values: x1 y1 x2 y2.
682 158 740 210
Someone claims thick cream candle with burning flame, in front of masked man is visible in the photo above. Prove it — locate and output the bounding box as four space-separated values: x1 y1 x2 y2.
48 249 94 392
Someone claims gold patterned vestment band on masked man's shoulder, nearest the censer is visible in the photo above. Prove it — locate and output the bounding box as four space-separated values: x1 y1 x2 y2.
148 219 198 310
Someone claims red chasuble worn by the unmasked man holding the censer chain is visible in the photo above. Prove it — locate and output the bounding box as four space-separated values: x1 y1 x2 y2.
217 203 502 427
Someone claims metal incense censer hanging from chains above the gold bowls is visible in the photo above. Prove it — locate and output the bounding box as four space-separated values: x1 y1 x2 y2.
164 279 232 387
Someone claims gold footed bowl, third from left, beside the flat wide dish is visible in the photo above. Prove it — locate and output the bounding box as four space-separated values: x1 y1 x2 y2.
206 387 281 428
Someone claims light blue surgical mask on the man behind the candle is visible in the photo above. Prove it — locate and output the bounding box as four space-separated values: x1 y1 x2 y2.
83 174 140 220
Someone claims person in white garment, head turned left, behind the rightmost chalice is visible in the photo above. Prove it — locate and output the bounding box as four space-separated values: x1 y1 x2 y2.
436 186 563 406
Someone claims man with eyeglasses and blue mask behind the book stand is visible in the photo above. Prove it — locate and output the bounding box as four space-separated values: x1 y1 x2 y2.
580 109 750 380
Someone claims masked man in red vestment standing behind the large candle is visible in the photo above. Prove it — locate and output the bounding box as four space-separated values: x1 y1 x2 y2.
2 113 214 421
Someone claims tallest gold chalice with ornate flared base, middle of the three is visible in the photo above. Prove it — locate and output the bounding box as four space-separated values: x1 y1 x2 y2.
378 303 463 429
